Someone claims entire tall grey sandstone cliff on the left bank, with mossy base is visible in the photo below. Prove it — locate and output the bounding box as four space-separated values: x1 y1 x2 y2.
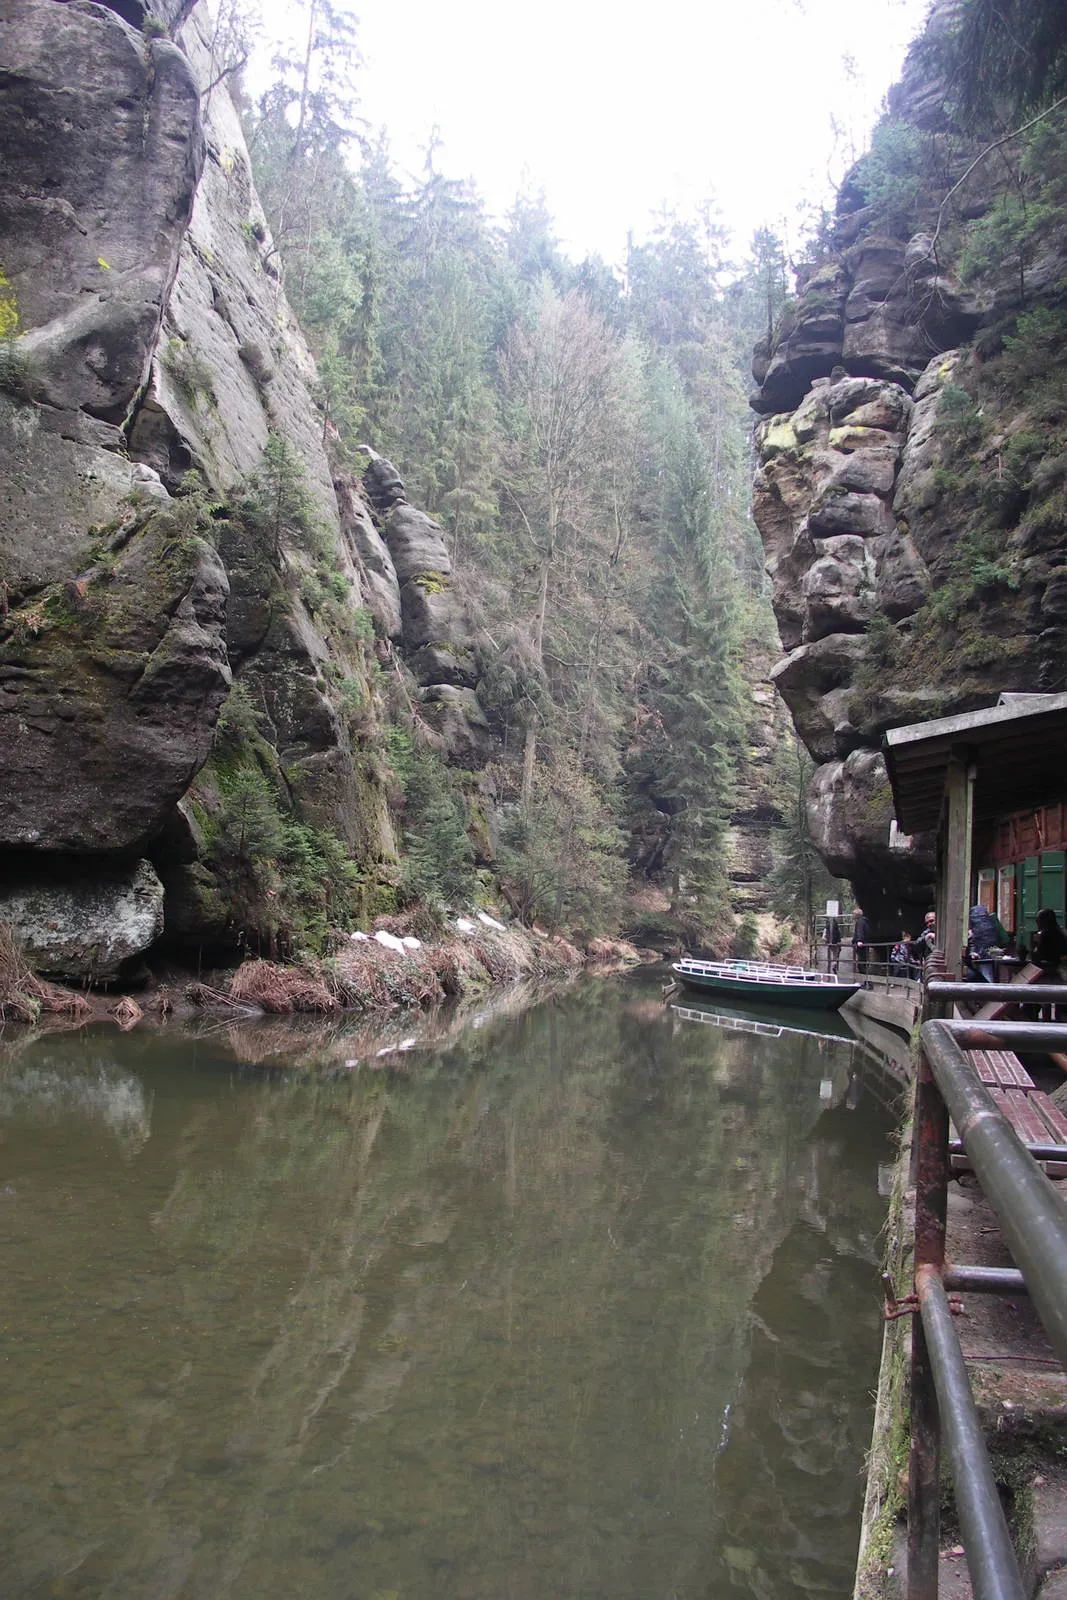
0 0 485 979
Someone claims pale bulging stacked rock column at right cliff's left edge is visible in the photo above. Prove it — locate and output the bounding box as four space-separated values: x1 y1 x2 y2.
753 361 933 925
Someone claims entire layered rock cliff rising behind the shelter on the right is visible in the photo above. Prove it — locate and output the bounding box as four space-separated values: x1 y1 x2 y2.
752 5 1067 931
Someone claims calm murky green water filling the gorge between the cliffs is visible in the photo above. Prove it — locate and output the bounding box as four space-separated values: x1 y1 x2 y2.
0 979 891 1600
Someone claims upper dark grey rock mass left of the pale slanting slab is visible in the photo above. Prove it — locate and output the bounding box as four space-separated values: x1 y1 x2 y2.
0 0 203 592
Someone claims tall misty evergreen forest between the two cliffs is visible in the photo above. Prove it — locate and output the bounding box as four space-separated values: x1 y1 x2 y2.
230 0 814 938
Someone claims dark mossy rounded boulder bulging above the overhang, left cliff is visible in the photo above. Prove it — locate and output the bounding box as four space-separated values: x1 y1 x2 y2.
0 512 230 853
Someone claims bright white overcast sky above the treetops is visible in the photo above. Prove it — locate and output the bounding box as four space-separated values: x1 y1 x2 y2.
253 0 928 264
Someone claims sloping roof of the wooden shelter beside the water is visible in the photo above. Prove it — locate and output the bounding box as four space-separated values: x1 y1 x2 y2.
883 694 1067 834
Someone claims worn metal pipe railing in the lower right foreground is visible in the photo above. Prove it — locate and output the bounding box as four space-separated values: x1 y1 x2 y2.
907 1017 1067 1600
